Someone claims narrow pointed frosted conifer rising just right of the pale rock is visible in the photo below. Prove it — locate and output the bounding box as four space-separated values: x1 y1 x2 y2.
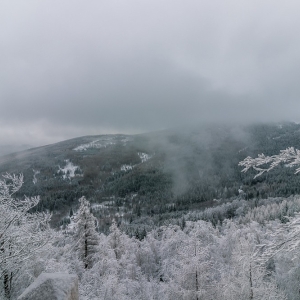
75 197 99 269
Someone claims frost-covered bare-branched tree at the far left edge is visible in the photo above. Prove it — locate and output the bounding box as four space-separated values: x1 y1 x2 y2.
0 174 51 299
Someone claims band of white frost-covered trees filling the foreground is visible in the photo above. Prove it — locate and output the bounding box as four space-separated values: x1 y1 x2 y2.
0 176 300 300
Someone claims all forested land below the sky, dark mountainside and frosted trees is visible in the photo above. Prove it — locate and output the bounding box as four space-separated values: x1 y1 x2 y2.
0 123 300 300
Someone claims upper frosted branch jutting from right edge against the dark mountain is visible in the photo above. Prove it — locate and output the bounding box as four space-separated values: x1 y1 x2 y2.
239 147 300 178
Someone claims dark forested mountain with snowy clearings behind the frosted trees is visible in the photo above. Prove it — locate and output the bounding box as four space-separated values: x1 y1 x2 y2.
0 123 300 231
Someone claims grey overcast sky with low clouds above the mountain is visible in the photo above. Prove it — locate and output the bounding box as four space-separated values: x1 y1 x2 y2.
0 0 300 145
